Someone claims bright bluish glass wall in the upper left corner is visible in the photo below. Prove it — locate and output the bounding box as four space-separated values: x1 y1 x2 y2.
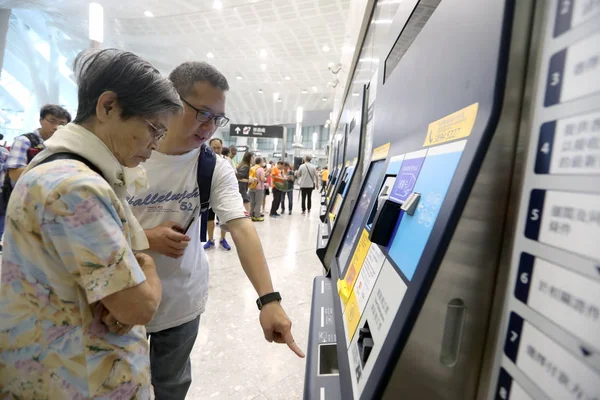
0 9 86 145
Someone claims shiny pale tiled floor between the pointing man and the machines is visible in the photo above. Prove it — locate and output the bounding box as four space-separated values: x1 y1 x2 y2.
188 192 322 400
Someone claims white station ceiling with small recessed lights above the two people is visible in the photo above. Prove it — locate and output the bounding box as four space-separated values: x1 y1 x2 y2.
21 0 354 123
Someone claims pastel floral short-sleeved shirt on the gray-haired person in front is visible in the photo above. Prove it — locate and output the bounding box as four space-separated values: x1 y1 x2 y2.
0 161 153 400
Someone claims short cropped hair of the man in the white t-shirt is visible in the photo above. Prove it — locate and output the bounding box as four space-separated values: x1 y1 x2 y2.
169 61 229 96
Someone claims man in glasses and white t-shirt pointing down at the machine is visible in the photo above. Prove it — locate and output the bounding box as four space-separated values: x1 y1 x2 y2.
129 62 304 400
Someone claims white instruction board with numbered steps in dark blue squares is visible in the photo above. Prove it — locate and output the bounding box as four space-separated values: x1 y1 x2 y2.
487 0 600 400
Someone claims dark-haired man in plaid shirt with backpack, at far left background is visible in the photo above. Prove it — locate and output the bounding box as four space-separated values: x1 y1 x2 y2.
2 104 71 186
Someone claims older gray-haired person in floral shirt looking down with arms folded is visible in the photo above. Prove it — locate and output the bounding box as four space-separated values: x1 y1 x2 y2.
0 49 181 399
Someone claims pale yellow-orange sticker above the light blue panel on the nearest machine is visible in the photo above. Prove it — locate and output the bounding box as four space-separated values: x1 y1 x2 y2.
423 103 479 147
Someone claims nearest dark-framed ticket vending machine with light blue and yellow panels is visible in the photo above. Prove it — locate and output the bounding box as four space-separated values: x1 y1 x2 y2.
305 0 576 400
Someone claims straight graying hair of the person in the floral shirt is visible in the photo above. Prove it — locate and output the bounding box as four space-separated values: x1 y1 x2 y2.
73 49 183 123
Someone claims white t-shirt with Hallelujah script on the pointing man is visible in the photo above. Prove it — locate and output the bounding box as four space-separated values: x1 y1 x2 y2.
128 149 247 332
